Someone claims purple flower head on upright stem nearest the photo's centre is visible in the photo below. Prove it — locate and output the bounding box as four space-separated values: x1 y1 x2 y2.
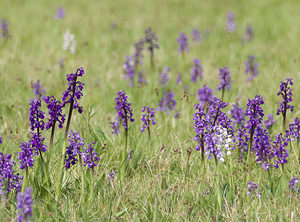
115 90 134 131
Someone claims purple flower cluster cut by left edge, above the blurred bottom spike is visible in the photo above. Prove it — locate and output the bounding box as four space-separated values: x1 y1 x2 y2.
0 152 23 195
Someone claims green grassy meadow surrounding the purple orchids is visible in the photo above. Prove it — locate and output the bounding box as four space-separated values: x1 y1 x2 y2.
0 0 300 221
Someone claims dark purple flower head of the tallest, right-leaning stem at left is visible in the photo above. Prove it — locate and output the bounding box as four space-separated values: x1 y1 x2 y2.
62 67 84 113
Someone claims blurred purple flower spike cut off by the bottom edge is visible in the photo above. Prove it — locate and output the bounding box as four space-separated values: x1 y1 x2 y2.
17 187 33 222
